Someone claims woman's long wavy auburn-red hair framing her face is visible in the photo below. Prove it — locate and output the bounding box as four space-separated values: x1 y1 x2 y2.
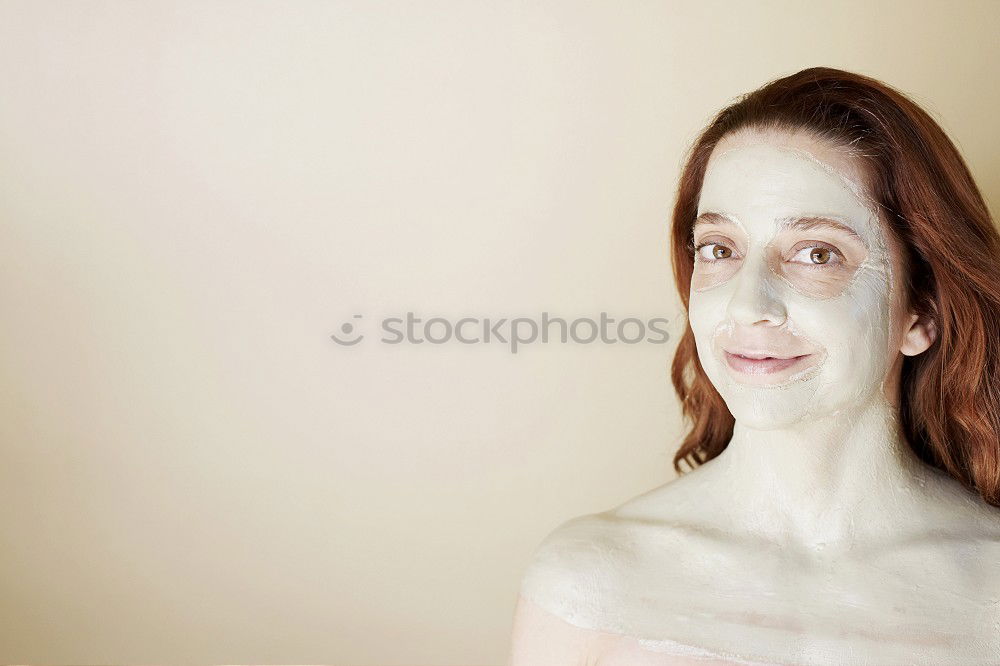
671 67 1000 506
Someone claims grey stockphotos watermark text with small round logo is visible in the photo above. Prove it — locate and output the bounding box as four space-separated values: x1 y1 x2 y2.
330 312 670 354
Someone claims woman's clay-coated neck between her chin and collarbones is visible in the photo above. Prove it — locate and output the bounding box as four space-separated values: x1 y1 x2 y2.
713 398 926 552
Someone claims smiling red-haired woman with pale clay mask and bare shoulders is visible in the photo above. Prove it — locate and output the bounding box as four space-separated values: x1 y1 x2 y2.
511 68 1000 666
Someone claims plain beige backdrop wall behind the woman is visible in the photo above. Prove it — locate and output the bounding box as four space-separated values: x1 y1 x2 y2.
0 0 1000 666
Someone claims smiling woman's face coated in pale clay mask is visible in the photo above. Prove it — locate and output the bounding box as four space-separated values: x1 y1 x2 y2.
688 127 911 428
